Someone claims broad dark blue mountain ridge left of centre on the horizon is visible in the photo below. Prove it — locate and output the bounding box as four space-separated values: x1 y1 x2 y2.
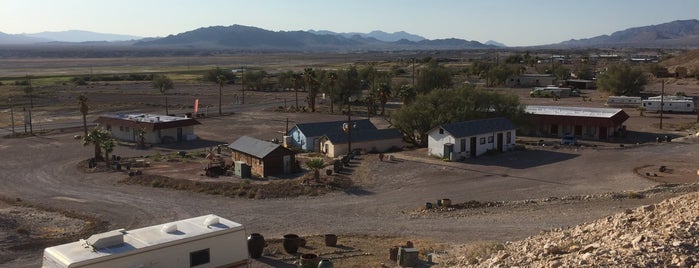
135 25 494 51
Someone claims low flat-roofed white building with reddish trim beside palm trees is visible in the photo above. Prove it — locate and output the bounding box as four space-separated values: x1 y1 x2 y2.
95 114 200 144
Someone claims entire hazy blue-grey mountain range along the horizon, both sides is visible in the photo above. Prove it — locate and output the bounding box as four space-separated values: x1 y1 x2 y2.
0 19 699 51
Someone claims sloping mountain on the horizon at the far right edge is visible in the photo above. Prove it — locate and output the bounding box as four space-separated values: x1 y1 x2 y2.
552 20 699 48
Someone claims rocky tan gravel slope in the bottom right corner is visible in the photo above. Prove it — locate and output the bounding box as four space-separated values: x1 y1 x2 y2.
456 193 699 268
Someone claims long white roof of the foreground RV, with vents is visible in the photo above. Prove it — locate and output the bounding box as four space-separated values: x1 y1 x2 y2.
45 214 243 267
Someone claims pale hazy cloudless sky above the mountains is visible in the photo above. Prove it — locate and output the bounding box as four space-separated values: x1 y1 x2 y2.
0 0 699 46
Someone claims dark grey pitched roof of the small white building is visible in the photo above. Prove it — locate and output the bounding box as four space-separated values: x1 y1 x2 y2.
440 117 516 138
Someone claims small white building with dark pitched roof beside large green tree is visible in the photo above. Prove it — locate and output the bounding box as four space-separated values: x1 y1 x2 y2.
427 117 516 160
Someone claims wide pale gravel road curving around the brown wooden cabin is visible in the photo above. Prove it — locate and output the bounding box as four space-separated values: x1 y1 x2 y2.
0 112 699 267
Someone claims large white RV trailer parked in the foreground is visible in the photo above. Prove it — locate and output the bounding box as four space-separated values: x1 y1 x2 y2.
42 214 248 268
